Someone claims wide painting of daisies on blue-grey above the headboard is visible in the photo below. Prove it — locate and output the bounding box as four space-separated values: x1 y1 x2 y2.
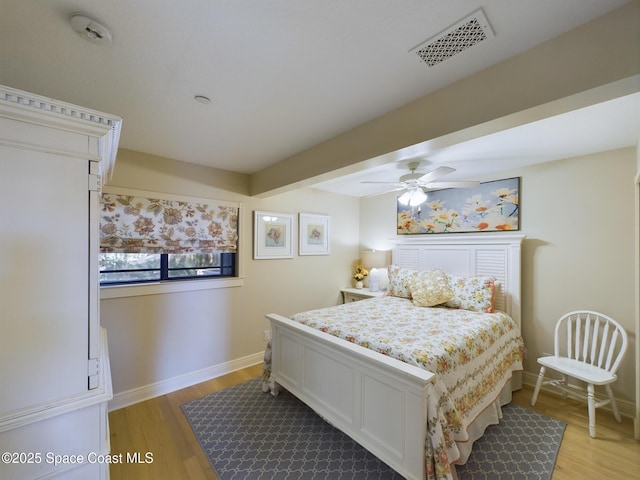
397 177 520 235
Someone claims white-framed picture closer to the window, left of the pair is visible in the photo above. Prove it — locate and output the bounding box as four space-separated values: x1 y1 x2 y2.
253 210 295 260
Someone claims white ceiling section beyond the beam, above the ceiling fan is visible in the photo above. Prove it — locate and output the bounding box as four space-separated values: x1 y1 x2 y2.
315 93 640 197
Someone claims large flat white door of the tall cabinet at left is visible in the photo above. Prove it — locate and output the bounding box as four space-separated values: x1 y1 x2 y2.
0 146 89 417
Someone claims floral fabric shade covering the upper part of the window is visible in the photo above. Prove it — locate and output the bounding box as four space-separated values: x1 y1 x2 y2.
100 193 239 253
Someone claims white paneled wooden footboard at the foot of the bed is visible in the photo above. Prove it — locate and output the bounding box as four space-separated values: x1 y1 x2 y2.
266 314 435 480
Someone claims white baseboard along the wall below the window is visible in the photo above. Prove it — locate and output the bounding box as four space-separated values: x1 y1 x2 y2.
109 352 264 412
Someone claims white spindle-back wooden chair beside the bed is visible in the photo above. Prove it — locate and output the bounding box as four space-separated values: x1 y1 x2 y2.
531 310 627 438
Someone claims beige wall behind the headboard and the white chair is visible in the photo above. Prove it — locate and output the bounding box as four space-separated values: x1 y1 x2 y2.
360 148 636 400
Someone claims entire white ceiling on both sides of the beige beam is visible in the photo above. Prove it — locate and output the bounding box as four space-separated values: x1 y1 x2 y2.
0 0 640 195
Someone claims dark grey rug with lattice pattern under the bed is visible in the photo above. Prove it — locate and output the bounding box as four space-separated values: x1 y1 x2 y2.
182 378 565 480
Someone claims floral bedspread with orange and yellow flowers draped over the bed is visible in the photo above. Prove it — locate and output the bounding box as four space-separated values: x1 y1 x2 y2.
265 296 524 480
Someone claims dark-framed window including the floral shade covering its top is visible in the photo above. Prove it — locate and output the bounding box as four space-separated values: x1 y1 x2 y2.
100 188 240 285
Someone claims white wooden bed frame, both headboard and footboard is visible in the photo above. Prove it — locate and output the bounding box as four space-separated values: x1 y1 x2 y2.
266 234 524 480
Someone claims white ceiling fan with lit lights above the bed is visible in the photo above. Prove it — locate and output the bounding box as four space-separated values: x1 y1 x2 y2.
361 162 479 207
